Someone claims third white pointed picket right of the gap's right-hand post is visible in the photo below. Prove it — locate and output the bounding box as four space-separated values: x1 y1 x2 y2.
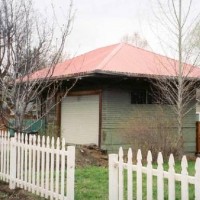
137 149 142 200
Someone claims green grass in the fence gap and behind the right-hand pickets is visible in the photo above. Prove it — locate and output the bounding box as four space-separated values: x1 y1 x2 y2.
75 161 195 200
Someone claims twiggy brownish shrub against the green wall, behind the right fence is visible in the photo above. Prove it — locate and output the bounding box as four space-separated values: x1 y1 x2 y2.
124 110 183 161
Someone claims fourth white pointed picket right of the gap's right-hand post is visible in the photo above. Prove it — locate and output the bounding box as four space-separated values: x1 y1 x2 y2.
147 151 153 200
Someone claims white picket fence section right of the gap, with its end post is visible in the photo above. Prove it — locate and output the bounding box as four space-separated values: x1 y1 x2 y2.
109 148 200 200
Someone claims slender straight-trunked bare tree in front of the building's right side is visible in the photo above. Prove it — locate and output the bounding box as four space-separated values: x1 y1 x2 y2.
153 0 199 141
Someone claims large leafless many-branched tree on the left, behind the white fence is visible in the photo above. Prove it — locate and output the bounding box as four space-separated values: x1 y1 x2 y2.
0 0 73 132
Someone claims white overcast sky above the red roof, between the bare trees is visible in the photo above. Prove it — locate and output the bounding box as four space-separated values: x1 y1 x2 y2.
34 0 200 55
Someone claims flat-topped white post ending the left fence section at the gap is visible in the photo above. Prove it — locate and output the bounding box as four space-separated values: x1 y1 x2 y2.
67 146 75 200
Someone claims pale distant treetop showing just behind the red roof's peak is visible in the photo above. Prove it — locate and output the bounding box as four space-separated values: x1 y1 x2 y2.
121 32 149 49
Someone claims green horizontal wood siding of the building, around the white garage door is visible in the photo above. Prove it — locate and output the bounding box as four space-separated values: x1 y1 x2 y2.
47 77 196 153
